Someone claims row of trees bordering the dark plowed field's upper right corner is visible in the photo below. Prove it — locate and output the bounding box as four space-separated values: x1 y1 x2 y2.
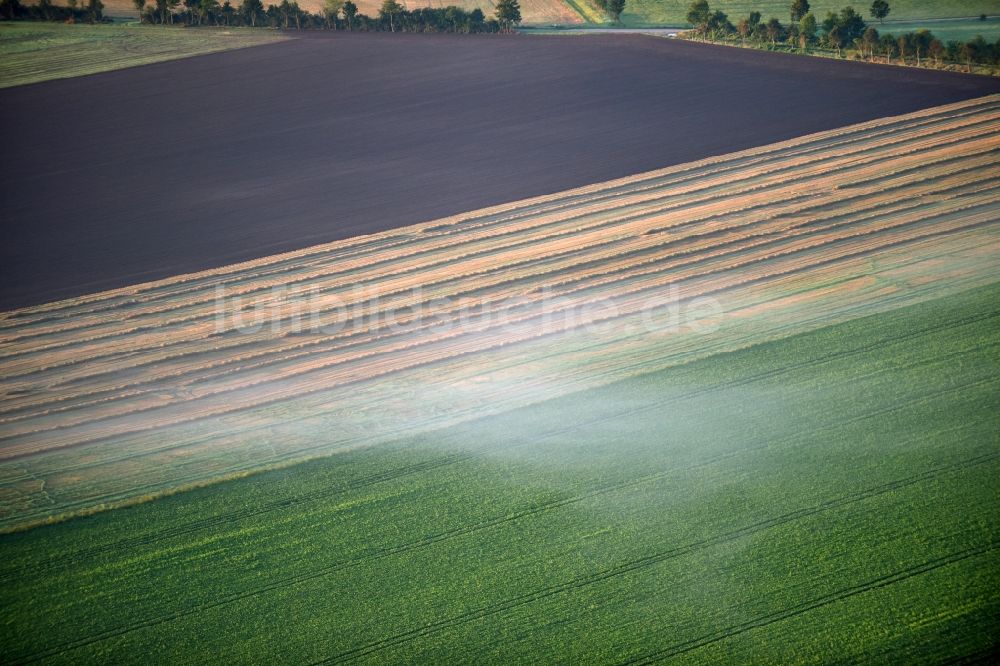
687 0 1000 69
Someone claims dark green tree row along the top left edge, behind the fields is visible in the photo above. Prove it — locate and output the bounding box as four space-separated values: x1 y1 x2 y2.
0 0 528 33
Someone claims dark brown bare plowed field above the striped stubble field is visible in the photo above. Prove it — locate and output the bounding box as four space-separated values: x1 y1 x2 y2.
0 34 1000 310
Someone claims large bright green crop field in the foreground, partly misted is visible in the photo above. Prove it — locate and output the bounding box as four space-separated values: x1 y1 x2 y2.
0 284 1000 663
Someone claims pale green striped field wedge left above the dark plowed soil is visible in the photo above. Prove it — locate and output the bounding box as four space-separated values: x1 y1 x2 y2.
0 22 285 88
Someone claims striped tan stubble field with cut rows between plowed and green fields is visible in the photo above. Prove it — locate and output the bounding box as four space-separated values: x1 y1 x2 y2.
0 96 1000 529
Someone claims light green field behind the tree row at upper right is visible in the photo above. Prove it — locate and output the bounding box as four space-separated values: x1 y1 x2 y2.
622 0 1000 29
